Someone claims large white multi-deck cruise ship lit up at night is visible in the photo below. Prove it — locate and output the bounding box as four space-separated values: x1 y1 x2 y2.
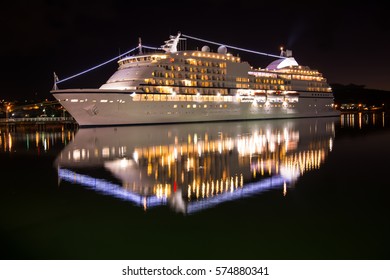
51 33 340 127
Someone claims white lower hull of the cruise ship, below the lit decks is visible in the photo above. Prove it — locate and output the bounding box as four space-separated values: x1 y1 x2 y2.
52 89 340 127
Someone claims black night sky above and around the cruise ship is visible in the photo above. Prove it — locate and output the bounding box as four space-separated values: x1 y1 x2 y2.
0 0 390 100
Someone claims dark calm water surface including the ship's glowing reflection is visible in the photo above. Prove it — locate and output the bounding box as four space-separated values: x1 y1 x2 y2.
0 113 390 260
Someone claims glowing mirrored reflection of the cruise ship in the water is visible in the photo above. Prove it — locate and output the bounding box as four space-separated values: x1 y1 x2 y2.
55 118 339 214
